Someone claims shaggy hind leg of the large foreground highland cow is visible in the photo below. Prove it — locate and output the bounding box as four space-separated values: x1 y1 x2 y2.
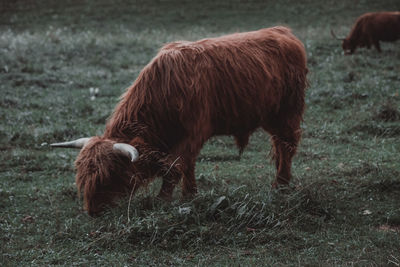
264 117 301 187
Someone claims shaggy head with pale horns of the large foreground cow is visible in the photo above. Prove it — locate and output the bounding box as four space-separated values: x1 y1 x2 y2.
51 137 139 216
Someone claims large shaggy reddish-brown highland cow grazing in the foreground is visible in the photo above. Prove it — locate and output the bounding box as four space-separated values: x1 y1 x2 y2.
52 27 307 215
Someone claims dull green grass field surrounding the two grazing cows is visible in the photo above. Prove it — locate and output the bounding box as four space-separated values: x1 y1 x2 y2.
0 0 400 266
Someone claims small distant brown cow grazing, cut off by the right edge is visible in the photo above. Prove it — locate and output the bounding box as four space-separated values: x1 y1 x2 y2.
331 12 400 54
